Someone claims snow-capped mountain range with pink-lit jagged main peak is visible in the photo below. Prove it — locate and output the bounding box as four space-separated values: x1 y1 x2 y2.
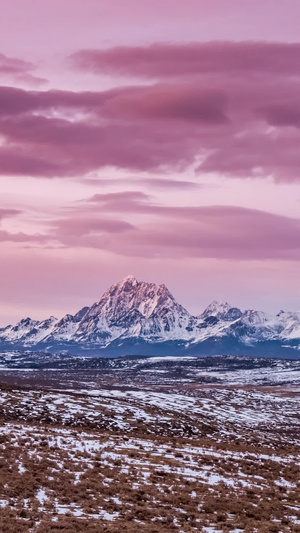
0 276 300 357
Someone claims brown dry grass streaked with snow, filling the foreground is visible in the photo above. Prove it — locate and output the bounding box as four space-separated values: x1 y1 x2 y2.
0 380 300 533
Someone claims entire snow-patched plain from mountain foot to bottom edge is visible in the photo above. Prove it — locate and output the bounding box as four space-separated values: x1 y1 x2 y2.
0 352 300 533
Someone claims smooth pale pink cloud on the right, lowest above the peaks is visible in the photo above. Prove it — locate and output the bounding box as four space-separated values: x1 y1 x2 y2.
126 211 300 260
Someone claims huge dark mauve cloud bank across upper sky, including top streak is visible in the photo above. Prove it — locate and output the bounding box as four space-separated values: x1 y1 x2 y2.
0 42 300 181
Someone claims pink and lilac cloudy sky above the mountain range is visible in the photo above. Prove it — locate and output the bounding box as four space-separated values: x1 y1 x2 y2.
0 0 300 325
